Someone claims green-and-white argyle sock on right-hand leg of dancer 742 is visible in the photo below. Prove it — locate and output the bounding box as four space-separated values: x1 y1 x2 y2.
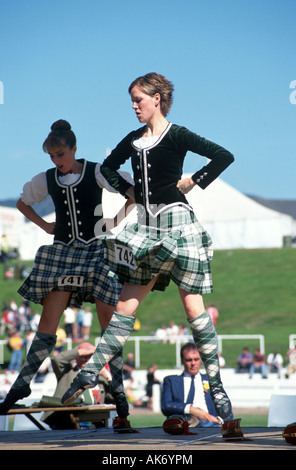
188 311 221 386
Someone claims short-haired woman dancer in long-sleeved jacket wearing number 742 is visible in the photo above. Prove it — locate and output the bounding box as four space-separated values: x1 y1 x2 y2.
62 73 234 418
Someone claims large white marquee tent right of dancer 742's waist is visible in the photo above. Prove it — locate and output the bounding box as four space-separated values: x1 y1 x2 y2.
187 179 296 249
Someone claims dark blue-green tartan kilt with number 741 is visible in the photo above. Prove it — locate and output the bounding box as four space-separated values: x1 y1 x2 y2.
18 240 122 308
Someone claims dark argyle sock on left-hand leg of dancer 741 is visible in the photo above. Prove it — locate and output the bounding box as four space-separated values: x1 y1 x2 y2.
12 331 57 388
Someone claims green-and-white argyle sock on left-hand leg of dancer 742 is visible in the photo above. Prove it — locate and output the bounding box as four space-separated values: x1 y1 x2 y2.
80 311 135 375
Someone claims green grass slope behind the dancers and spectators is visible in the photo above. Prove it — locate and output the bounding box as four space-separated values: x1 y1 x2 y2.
0 247 296 369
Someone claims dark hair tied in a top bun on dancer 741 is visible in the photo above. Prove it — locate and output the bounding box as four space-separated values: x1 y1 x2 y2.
42 119 76 153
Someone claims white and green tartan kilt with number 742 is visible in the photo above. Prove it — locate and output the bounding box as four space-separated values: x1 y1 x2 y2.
102 206 213 294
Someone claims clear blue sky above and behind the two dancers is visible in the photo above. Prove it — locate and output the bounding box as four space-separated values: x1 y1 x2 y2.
0 0 296 200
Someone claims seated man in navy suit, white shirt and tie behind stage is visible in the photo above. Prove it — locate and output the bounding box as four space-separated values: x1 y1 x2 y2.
161 343 232 426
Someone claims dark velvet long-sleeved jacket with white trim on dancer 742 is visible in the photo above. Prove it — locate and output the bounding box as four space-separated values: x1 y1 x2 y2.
101 123 234 216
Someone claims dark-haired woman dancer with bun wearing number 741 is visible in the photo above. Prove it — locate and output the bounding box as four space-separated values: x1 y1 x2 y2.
0 120 132 426
